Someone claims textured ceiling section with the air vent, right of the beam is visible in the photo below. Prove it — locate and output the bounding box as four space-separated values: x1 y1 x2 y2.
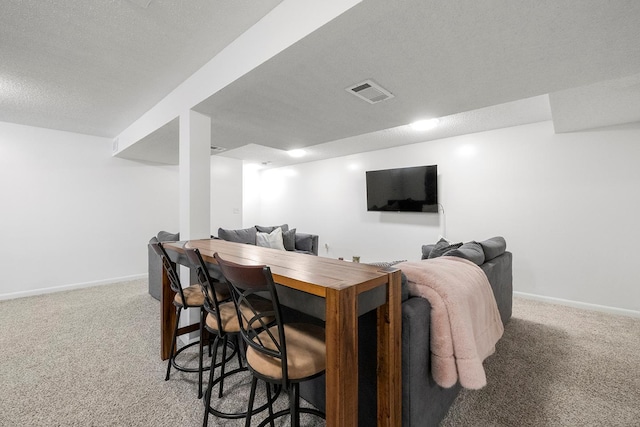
196 0 640 154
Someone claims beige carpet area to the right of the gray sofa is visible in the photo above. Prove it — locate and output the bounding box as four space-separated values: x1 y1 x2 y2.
441 298 640 427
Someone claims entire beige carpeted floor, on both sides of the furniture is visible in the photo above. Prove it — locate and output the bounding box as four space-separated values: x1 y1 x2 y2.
0 280 640 427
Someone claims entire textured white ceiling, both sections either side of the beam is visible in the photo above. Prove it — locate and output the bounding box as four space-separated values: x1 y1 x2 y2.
0 0 640 166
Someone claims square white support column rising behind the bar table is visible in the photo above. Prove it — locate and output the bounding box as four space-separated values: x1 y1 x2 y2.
179 110 211 338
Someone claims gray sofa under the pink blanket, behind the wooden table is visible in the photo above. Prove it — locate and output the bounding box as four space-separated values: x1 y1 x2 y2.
300 237 513 427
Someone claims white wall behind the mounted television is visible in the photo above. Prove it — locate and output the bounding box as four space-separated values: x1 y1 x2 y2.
245 122 640 312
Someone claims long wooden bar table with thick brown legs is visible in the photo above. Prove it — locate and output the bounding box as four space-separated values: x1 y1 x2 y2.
160 239 402 427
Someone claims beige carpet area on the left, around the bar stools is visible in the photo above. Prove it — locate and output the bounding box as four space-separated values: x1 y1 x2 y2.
0 280 324 427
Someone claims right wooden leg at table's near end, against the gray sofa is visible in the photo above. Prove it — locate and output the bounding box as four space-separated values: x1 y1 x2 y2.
378 270 402 427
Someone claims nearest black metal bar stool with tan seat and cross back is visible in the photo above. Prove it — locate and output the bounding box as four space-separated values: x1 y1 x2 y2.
214 253 326 427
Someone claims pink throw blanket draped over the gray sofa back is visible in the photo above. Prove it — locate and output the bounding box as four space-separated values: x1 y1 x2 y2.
396 256 504 389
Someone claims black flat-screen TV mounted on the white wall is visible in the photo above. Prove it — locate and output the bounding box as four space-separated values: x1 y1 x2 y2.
367 165 438 212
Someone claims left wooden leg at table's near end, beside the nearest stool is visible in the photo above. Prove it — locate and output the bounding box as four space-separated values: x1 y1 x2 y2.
325 287 358 427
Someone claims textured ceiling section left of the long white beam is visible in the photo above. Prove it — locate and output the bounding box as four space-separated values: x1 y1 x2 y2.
0 0 281 137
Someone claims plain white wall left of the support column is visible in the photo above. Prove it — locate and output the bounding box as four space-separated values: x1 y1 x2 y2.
0 123 178 299
